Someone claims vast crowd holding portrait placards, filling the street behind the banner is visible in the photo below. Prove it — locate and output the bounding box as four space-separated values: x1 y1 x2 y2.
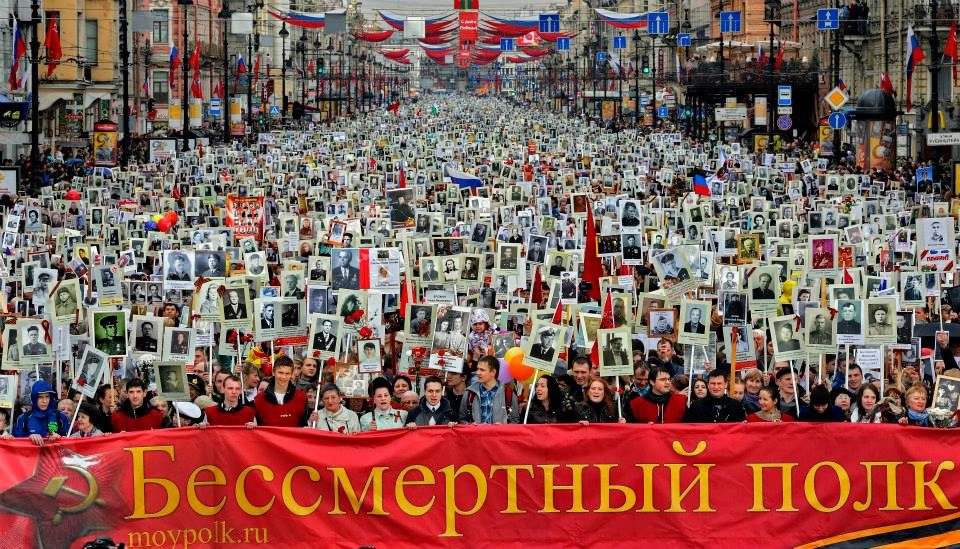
0 93 960 444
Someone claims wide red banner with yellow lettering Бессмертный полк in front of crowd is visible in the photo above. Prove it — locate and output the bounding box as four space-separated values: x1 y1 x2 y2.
0 424 960 549
